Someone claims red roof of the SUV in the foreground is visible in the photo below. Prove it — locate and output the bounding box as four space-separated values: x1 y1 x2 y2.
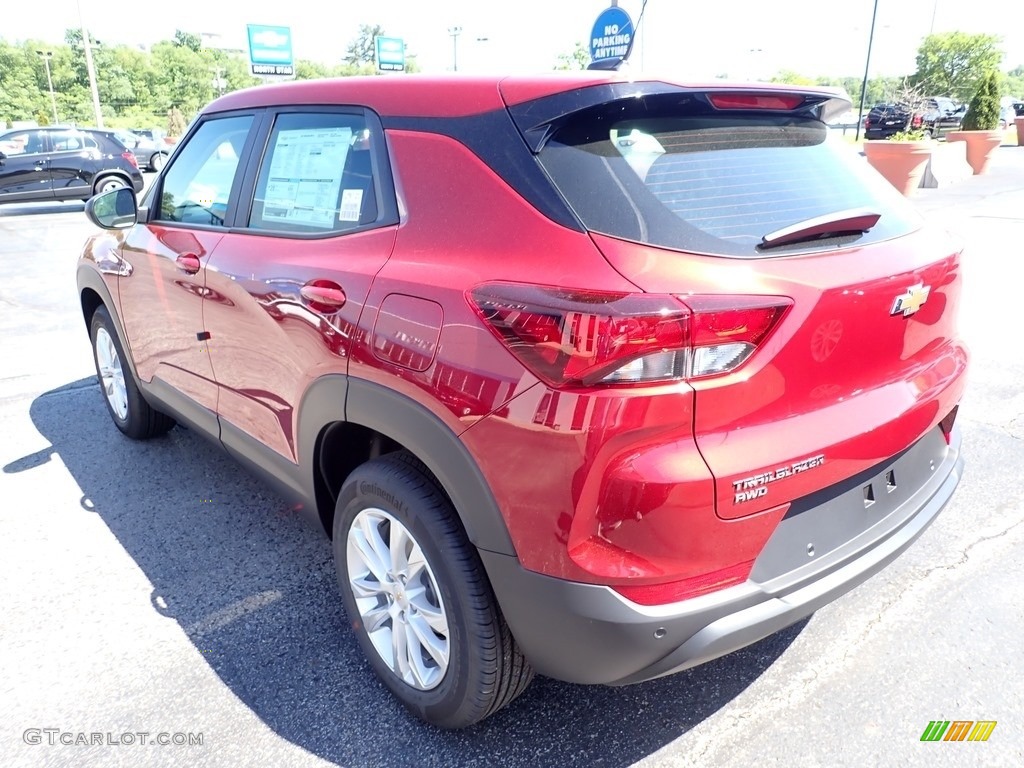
203 71 849 118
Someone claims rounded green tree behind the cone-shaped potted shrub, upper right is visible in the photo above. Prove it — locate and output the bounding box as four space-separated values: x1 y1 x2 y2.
913 32 1002 101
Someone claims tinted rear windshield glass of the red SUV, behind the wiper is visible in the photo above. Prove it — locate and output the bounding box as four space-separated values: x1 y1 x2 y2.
540 99 920 257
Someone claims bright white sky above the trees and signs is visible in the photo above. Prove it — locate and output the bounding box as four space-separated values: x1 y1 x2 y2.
0 0 1024 80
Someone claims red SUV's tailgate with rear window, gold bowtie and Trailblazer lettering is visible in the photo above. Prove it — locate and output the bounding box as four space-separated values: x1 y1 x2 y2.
540 88 967 518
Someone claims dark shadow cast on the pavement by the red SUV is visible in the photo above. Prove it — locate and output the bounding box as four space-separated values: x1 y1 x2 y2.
3 379 806 767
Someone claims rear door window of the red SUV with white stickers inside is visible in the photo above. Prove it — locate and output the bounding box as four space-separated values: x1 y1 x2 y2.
249 113 379 234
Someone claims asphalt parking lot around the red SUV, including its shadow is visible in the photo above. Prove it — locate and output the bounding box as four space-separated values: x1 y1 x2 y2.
6 153 1024 768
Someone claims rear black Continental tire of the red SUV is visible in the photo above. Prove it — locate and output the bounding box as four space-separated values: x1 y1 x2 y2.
334 452 534 728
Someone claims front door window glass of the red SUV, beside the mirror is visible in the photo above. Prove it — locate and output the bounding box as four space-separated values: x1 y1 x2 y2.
156 115 253 226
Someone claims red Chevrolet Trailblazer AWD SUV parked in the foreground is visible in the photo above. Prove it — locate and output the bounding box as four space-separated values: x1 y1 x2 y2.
78 73 968 727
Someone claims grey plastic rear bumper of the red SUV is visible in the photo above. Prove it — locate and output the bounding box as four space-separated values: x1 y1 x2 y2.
480 429 964 685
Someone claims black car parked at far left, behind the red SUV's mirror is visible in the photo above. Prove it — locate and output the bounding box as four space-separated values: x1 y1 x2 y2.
0 128 142 203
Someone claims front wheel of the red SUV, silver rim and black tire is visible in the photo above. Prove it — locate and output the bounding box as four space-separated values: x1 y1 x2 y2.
89 305 174 440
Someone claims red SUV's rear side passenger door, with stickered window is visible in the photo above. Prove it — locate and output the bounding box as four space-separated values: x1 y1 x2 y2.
201 108 398 464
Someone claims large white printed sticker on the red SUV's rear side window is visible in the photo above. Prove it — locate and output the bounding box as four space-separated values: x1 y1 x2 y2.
263 128 358 229
